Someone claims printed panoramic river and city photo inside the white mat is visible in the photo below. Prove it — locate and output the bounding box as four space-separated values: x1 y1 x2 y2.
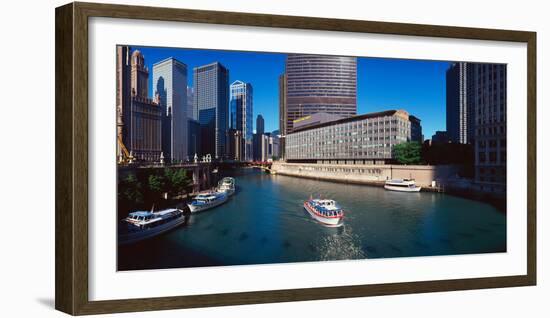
116 46 509 270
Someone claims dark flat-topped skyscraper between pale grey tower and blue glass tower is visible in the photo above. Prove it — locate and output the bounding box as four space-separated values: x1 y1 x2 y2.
193 62 229 159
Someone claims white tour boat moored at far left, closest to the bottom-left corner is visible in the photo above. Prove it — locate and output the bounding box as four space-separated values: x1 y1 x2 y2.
118 209 185 245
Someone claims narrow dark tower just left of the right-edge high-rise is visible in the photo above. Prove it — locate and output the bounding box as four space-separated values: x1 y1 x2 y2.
446 62 474 144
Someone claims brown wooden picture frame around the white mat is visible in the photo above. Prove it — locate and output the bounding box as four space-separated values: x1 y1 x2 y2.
55 2 536 315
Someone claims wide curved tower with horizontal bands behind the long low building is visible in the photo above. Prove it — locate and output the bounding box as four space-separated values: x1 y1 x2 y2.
285 54 357 134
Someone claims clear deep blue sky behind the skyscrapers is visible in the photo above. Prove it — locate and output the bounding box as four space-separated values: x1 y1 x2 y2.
132 47 449 139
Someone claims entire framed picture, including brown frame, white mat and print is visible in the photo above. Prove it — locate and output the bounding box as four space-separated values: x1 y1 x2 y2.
55 3 536 315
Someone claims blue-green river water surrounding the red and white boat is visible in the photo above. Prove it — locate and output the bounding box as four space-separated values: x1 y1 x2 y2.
118 169 506 270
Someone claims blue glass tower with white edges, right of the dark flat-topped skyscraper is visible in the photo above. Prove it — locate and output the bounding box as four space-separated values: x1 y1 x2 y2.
229 81 253 160
